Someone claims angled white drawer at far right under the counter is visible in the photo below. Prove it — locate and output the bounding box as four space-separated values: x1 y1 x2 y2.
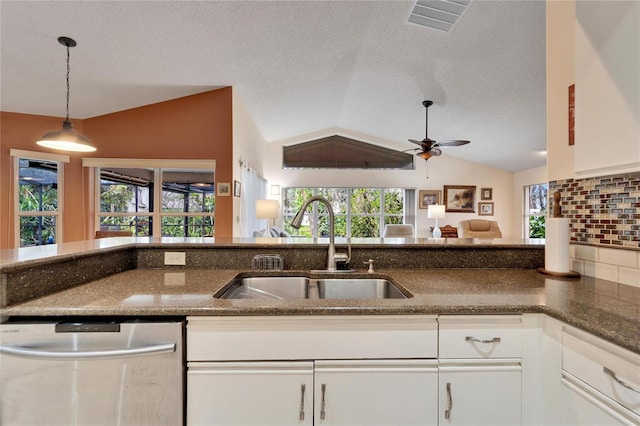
562 330 640 414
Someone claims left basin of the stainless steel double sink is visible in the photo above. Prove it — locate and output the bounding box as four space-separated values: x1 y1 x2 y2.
214 277 309 299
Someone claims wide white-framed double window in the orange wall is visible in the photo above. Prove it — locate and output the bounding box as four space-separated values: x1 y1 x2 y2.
85 159 215 237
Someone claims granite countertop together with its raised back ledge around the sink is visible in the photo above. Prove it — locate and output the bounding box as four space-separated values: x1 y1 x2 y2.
0 238 640 353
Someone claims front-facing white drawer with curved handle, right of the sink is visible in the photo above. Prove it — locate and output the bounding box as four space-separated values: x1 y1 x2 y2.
438 315 522 358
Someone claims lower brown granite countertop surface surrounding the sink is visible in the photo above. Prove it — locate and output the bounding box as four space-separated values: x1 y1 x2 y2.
2 269 640 353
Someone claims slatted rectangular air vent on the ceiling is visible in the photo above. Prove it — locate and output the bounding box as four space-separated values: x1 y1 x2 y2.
407 0 471 32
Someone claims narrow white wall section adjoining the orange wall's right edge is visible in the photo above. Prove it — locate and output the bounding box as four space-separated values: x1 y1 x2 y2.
231 89 266 237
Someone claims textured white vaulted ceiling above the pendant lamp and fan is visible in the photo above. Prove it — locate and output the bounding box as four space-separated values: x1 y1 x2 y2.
0 0 546 170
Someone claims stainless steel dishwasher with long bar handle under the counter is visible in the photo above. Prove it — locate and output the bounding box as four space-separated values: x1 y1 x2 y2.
0 320 184 426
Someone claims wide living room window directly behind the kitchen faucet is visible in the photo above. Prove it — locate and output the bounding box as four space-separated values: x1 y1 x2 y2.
283 188 415 238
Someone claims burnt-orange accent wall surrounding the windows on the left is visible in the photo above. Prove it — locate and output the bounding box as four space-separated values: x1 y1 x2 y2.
0 87 233 248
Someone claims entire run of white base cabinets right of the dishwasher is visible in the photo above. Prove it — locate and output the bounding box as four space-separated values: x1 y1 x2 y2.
187 314 640 426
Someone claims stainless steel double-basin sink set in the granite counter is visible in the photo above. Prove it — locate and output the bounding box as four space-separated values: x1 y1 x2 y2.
214 275 412 300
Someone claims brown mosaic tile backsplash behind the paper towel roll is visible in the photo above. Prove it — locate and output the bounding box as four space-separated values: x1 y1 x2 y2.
549 172 640 249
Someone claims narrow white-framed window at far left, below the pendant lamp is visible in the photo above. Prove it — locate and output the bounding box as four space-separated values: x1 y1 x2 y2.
11 150 69 247
